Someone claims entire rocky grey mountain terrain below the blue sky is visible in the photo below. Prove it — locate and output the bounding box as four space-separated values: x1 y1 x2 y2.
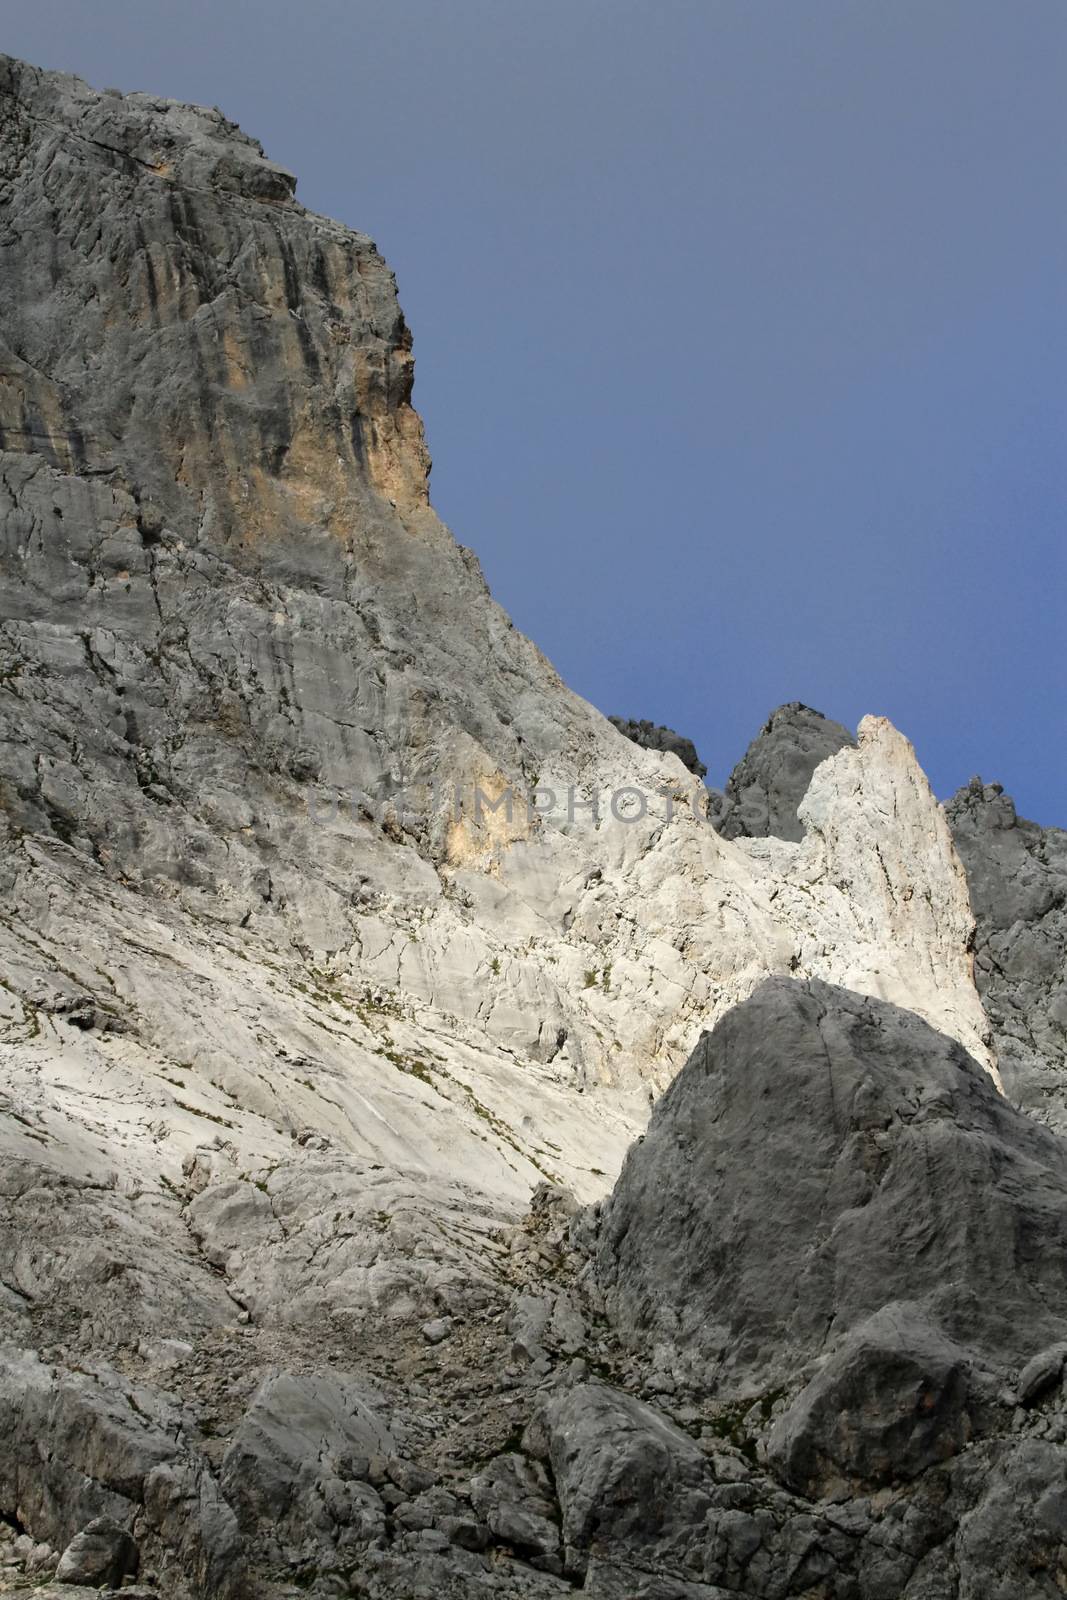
0 58 1067 1600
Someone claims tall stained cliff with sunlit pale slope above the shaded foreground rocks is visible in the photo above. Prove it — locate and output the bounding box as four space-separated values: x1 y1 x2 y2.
0 50 1004 1195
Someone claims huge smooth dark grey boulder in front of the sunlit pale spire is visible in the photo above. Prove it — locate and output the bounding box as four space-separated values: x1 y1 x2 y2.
597 979 1067 1395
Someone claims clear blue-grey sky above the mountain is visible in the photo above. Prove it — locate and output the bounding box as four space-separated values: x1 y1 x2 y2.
0 0 1067 824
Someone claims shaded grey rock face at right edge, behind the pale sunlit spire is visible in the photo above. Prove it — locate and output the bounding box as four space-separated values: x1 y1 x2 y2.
945 778 1067 1131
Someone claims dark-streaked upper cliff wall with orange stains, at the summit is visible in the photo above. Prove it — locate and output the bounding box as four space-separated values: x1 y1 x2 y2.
0 58 427 547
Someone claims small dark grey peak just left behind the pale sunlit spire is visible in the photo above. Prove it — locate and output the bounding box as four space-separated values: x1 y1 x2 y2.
717 701 856 840
